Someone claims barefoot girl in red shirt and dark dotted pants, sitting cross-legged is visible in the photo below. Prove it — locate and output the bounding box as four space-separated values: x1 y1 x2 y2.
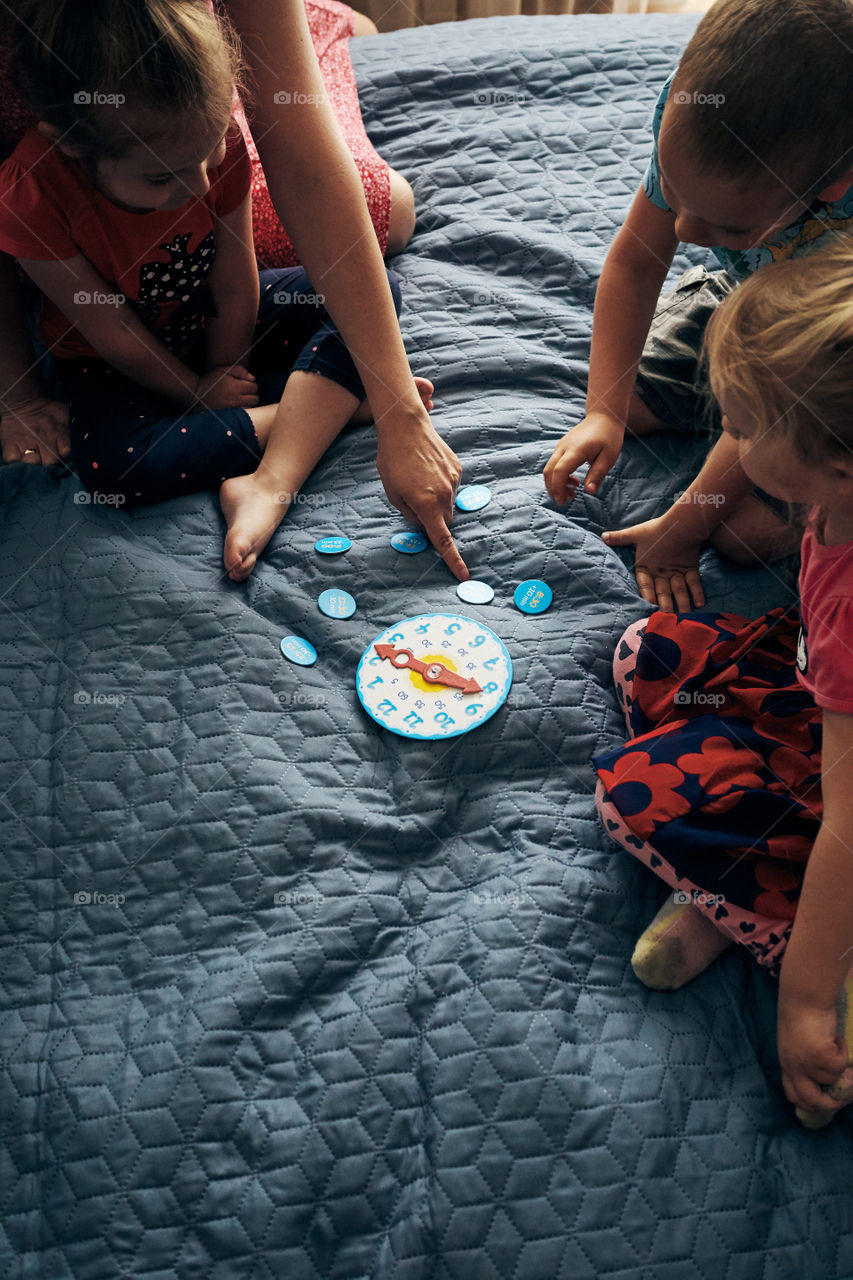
0 0 432 581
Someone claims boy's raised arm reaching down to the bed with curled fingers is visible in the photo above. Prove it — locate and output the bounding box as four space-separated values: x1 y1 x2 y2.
544 187 678 502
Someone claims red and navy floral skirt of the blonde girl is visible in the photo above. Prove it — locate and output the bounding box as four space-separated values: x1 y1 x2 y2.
594 609 822 973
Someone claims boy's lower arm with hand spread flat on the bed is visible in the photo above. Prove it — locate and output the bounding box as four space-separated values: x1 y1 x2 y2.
601 433 752 613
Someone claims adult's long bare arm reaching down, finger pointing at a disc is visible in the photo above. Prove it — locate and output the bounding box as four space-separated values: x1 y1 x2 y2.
223 0 469 579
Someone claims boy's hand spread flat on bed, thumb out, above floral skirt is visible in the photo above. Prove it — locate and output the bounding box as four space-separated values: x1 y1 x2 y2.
601 516 704 613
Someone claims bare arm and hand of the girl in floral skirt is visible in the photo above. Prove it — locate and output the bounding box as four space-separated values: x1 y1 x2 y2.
779 710 853 1111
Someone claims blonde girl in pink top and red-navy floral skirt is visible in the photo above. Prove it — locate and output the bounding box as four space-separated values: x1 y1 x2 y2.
596 236 853 1124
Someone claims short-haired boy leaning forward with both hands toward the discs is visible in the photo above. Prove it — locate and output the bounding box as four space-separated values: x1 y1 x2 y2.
544 0 853 609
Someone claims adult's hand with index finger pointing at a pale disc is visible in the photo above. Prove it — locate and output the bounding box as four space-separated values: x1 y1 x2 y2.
377 411 471 582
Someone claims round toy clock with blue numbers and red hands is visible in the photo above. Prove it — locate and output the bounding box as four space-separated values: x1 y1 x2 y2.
356 613 512 739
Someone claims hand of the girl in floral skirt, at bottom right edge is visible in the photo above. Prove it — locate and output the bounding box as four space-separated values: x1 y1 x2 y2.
776 997 847 1112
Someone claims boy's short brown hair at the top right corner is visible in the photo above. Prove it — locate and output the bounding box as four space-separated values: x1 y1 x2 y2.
666 0 853 197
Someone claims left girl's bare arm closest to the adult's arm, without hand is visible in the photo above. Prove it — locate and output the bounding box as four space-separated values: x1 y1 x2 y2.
205 195 260 369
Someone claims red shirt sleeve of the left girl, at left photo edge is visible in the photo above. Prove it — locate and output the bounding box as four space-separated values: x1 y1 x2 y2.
0 129 79 261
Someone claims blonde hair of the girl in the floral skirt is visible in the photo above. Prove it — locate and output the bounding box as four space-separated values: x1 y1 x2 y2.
704 234 853 462
